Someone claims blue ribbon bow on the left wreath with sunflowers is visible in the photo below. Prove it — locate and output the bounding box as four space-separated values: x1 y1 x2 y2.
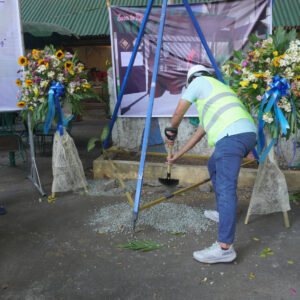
44 81 73 135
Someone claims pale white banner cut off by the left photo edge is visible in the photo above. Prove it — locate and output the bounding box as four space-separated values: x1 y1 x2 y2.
0 0 23 111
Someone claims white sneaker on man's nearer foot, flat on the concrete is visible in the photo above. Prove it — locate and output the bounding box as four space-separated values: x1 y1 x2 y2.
193 242 236 264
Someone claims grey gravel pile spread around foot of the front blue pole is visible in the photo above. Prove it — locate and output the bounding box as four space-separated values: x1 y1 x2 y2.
90 203 213 233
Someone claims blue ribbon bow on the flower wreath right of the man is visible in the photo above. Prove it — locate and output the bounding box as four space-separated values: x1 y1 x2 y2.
257 75 296 165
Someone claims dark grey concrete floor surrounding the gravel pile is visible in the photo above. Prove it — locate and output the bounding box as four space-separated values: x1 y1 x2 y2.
0 111 300 300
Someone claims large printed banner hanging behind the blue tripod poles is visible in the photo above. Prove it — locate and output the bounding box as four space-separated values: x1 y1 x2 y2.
110 0 272 117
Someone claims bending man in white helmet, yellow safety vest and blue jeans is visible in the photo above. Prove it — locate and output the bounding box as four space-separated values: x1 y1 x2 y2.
166 65 256 263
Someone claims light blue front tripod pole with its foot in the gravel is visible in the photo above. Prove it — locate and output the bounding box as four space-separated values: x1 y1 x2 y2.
133 0 168 229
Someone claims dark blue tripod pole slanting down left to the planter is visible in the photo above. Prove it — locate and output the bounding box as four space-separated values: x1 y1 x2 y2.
103 0 154 149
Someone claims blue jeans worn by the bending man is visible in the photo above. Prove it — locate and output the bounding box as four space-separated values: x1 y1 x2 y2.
207 132 256 244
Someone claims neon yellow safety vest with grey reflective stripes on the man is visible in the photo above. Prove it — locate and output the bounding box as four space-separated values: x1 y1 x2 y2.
196 76 255 146
